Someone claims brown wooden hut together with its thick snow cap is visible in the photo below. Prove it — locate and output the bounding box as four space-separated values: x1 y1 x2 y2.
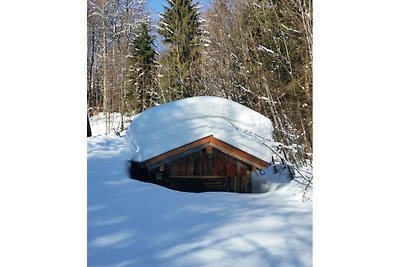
125 96 273 192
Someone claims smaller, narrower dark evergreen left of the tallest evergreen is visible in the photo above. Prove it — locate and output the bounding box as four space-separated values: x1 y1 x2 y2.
127 23 158 112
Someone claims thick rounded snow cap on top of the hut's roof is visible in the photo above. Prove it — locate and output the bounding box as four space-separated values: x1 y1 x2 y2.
125 96 273 162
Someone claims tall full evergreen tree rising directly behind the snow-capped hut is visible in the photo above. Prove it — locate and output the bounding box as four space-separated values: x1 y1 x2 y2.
158 0 202 100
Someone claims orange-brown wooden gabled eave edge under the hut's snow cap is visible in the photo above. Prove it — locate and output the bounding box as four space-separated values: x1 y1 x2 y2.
143 135 268 169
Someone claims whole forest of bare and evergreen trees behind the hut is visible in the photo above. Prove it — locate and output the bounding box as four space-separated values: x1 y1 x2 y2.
87 0 313 166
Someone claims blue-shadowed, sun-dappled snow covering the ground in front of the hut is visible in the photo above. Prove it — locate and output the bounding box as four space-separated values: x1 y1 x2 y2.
88 136 312 267
